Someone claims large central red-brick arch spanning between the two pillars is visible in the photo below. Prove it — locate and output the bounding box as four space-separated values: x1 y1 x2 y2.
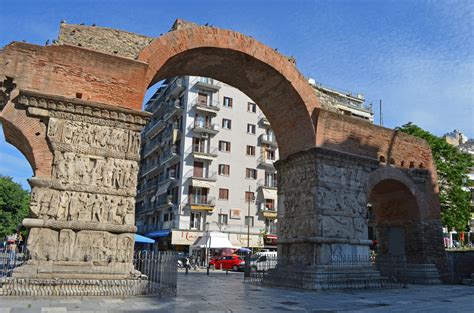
138 26 320 158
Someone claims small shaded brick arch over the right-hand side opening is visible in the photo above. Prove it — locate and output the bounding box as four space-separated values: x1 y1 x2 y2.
367 166 430 220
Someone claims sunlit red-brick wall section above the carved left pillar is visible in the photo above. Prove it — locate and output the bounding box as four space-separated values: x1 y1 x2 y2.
0 42 147 110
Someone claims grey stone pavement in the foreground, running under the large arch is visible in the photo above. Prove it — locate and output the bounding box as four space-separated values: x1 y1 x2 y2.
0 270 474 313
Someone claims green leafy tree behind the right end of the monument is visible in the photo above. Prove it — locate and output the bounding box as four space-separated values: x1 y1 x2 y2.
400 123 474 231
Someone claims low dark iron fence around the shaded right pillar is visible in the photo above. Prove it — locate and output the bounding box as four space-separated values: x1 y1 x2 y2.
245 255 449 290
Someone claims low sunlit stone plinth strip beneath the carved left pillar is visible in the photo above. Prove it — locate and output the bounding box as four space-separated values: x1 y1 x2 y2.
0 278 176 297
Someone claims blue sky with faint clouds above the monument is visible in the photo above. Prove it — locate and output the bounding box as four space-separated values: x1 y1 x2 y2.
0 0 474 187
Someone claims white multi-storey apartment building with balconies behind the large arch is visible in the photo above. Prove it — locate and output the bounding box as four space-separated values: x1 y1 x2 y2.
136 76 373 251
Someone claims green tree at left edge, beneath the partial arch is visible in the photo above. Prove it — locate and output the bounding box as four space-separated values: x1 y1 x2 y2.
0 175 30 239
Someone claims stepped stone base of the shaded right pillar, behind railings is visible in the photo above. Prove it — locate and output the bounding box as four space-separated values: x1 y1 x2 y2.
262 265 387 290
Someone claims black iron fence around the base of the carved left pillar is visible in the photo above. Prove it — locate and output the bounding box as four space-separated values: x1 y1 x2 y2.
0 250 178 297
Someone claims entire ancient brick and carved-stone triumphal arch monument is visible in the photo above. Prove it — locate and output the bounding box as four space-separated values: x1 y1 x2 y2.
0 20 443 294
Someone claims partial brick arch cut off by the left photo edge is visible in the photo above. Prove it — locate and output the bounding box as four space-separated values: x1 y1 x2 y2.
0 102 53 177
